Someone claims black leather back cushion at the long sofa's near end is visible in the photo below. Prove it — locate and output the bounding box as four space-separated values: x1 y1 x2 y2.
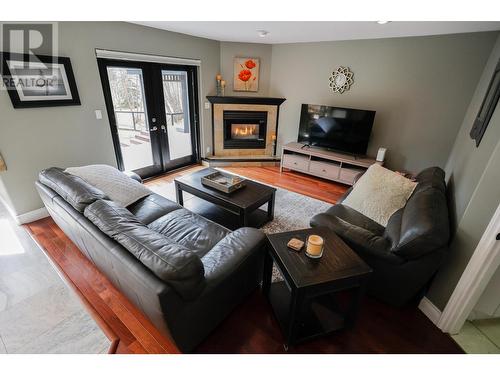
84 200 205 299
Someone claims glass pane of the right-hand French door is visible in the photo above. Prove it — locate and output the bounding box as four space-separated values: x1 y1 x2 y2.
162 70 193 160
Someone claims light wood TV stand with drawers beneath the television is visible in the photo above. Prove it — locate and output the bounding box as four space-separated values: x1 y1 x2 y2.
280 142 381 185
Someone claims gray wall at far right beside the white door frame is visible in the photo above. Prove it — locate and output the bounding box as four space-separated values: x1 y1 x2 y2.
427 37 500 309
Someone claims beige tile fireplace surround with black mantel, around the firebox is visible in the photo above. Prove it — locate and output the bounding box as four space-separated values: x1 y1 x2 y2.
207 96 285 159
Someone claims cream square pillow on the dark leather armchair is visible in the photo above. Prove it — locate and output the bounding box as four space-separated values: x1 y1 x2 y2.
342 164 417 227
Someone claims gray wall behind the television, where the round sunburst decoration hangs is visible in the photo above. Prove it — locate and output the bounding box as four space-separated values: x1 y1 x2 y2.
271 33 497 171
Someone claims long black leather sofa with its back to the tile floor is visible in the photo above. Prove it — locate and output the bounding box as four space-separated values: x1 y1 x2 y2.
36 168 265 352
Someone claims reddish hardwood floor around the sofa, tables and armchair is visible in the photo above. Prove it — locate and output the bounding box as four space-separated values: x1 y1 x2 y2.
25 166 462 353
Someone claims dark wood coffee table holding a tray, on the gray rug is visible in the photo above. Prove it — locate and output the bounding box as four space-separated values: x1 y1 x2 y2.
175 168 276 229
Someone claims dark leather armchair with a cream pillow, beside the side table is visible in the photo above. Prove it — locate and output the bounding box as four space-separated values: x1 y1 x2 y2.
311 167 450 306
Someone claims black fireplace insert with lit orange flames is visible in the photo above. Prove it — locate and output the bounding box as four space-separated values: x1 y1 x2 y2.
223 111 267 149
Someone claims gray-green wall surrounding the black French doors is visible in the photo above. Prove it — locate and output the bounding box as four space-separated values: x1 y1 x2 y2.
0 22 220 214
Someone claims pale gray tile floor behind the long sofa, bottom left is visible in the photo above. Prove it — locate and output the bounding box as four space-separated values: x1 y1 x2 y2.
0 203 110 354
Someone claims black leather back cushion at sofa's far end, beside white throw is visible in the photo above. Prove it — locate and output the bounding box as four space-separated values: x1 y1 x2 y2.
38 167 107 212
